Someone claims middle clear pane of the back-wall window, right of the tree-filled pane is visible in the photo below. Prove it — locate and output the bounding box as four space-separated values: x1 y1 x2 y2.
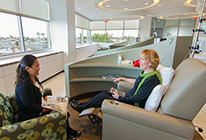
106 30 123 42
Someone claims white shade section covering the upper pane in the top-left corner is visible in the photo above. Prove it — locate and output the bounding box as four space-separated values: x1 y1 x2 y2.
0 0 19 13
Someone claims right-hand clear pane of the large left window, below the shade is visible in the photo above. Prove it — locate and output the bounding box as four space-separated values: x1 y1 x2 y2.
22 17 48 51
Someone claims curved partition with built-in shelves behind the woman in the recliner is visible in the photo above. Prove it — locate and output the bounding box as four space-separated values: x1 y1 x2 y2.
64 37 192 97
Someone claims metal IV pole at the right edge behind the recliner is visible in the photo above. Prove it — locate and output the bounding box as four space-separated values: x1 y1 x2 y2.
190 0 205 58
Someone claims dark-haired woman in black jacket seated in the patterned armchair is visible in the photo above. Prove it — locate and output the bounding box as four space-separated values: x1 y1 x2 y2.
15 55 81 140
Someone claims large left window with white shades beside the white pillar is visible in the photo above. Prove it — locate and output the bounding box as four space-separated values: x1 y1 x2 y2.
0 0 50 55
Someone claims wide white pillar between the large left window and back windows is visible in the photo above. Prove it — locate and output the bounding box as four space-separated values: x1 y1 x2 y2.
49 0 76 64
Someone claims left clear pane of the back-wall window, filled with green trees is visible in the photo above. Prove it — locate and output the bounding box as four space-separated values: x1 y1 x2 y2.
91 30 105 42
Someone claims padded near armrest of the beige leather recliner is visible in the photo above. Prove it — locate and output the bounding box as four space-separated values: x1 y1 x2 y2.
102 100 194 139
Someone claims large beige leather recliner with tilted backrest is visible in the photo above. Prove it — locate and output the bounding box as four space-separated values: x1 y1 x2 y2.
102 58 206 140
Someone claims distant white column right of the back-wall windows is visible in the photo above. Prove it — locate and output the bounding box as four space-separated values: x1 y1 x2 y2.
139 17 152 41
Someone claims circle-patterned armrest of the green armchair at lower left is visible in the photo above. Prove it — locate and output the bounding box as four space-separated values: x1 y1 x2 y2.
0 112 66 140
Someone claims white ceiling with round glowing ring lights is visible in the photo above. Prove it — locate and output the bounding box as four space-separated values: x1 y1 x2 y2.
75 0 203 20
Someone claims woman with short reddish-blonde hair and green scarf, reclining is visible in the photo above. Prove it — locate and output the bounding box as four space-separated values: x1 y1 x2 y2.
70 49 161 113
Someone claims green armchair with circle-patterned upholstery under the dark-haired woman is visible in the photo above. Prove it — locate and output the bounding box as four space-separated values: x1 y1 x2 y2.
0 93 66 140
